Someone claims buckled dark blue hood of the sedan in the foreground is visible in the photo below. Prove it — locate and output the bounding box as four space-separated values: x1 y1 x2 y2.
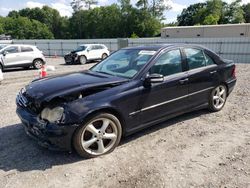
26 71 127 102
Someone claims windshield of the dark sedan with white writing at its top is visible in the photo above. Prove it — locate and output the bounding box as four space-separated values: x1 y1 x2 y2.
90 49 156 78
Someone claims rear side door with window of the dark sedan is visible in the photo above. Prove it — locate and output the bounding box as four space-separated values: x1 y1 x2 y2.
183 48 219 107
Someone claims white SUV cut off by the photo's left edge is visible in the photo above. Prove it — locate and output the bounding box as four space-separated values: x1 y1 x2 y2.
0 44 46 70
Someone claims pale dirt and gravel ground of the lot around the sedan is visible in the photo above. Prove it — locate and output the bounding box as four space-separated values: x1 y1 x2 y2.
0 59 250 188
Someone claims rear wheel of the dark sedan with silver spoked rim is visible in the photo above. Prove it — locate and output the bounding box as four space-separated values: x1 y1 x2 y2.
209 85 227 112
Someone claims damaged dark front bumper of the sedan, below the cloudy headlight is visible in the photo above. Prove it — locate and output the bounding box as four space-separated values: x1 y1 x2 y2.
16 106 77 151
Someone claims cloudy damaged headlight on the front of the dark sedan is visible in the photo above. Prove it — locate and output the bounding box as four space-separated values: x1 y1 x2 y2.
41 107 64 123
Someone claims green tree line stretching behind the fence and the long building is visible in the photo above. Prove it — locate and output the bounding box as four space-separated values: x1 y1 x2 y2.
0 0 250 39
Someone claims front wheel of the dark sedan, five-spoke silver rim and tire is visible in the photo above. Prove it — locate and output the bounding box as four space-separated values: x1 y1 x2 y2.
73 113 122 158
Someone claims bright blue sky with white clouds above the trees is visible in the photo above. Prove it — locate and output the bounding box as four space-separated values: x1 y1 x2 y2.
0 0 250 23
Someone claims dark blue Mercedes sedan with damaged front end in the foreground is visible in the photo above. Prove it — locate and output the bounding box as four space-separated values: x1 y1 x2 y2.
16 45 236 157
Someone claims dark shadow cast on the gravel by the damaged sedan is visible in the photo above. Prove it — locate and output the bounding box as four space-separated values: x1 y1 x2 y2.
0 110 208 172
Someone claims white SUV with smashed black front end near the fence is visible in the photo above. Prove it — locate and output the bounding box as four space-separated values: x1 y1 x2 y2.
64 44 110 64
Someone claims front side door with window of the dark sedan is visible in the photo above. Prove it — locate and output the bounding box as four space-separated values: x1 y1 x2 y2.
140 49 188 125
